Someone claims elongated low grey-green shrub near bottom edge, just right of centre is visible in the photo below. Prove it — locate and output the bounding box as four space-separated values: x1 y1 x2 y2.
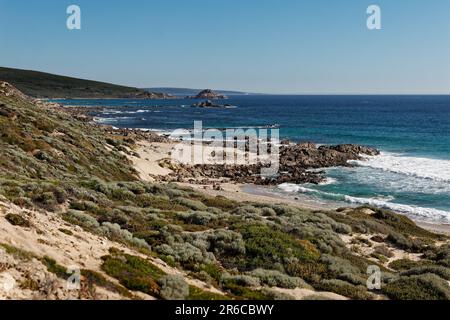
248 269 312 289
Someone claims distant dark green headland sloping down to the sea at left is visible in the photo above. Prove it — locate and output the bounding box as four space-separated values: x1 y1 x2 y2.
0 67 170 99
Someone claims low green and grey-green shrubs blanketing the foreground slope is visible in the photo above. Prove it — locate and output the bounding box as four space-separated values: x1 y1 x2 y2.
0 83 450 299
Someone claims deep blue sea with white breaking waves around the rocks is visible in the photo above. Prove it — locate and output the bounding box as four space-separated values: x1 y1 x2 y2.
54 95 450 223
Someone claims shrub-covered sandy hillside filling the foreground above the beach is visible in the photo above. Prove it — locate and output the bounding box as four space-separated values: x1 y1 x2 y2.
0 83 450 300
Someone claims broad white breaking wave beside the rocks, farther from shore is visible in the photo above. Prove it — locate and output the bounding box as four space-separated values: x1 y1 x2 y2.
349 153 450 182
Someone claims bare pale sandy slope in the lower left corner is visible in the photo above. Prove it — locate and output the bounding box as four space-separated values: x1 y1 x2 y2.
0 198 221 299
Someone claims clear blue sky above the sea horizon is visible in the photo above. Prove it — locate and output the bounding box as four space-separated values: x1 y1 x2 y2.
0 0 450 94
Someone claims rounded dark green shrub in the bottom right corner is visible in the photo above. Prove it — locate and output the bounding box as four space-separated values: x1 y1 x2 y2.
382 274 450 300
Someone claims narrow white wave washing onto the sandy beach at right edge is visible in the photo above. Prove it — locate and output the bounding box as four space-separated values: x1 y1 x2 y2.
344 196 450 222
